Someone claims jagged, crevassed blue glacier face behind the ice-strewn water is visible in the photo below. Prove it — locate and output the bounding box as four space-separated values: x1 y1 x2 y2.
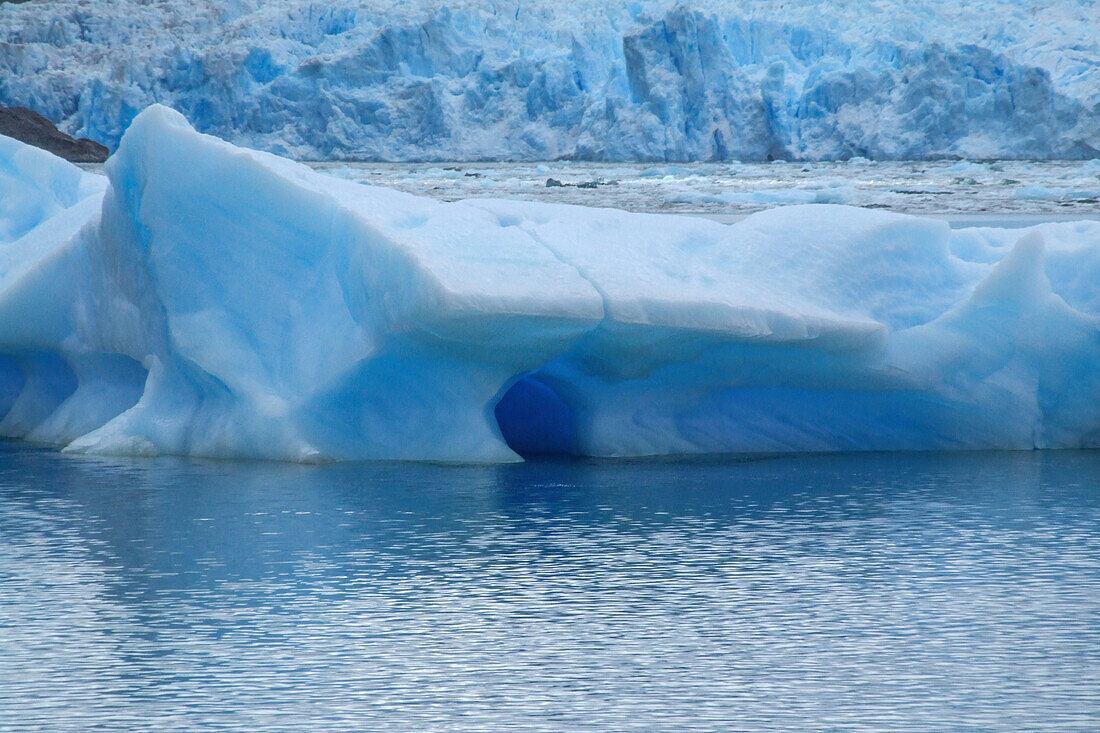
0 0 1100 161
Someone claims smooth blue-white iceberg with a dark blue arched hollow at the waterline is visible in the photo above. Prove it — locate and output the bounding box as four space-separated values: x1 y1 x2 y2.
0 107 1100 461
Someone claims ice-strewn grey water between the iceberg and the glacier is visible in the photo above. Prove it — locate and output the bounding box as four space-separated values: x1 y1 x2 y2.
310 158 1100 217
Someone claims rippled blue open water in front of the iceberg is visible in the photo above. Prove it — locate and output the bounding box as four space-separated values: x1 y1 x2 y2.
0 435 1100 731
